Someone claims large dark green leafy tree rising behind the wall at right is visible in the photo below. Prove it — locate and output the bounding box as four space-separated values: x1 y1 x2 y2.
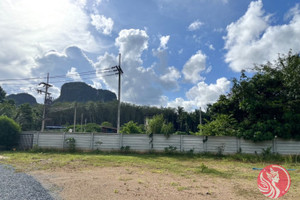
207 52 300 141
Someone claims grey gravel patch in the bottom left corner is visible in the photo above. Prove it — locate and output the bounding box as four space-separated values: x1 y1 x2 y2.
0 164 54 200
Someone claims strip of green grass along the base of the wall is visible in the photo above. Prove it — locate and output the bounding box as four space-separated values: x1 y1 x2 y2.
0 151 300 182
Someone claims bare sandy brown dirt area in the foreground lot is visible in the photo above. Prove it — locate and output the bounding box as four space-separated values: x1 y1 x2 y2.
31 167 295 200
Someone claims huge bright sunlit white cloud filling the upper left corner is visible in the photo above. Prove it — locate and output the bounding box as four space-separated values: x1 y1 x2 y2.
0 0 100 95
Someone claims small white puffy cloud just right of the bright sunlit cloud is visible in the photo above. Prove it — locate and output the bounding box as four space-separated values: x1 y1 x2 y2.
91 14 114 35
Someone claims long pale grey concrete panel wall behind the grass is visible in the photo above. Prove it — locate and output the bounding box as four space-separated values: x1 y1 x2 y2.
20 132 300 155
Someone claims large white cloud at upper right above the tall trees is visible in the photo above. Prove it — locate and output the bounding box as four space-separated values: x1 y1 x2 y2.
224 0 300 72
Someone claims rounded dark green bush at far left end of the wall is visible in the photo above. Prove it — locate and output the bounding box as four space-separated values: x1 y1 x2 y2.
0 116 21 149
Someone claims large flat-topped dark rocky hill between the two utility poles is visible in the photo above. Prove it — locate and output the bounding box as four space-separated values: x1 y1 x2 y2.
55 82 117 102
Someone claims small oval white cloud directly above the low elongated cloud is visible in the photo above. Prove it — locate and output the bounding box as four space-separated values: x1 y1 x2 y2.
182 50 206 83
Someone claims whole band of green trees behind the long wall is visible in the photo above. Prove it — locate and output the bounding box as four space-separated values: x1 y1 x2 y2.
0 52 300 141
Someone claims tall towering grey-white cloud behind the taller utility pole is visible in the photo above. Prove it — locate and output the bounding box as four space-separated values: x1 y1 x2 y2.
95 29 166 105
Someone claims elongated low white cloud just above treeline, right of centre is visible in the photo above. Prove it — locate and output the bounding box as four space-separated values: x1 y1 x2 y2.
167 77 230 111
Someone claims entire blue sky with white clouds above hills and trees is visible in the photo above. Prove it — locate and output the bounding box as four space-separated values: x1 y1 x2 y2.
0 0 300 111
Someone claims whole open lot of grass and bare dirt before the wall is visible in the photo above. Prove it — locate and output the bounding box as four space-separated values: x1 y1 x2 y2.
0 151 300 199
